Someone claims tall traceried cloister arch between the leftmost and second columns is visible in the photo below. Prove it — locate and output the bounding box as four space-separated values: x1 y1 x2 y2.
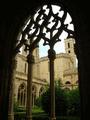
17 83 26 106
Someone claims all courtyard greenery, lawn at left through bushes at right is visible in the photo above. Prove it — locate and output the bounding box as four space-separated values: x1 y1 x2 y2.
14 81 80 120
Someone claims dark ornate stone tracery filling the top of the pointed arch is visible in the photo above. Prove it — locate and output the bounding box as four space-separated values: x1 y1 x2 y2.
16 4 74 53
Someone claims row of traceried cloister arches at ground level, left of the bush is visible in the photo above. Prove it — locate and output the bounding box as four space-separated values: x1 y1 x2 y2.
15 83 45 107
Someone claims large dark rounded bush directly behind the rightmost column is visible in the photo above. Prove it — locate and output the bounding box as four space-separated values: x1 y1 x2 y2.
41 81 67 116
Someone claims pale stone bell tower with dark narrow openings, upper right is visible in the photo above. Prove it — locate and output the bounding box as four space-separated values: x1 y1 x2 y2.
64 38 76 67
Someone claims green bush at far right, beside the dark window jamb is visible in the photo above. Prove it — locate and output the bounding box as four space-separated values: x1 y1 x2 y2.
66 88 80 116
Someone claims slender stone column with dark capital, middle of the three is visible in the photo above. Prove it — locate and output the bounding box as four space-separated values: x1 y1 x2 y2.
26 53 34 120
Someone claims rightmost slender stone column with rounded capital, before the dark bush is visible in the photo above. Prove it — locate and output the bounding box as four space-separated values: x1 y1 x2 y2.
48 49 56 120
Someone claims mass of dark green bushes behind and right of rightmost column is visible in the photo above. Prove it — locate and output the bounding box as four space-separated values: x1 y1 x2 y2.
36 81 80 116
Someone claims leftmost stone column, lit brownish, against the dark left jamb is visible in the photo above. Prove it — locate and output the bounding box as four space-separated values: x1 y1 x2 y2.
8 58 17 120
